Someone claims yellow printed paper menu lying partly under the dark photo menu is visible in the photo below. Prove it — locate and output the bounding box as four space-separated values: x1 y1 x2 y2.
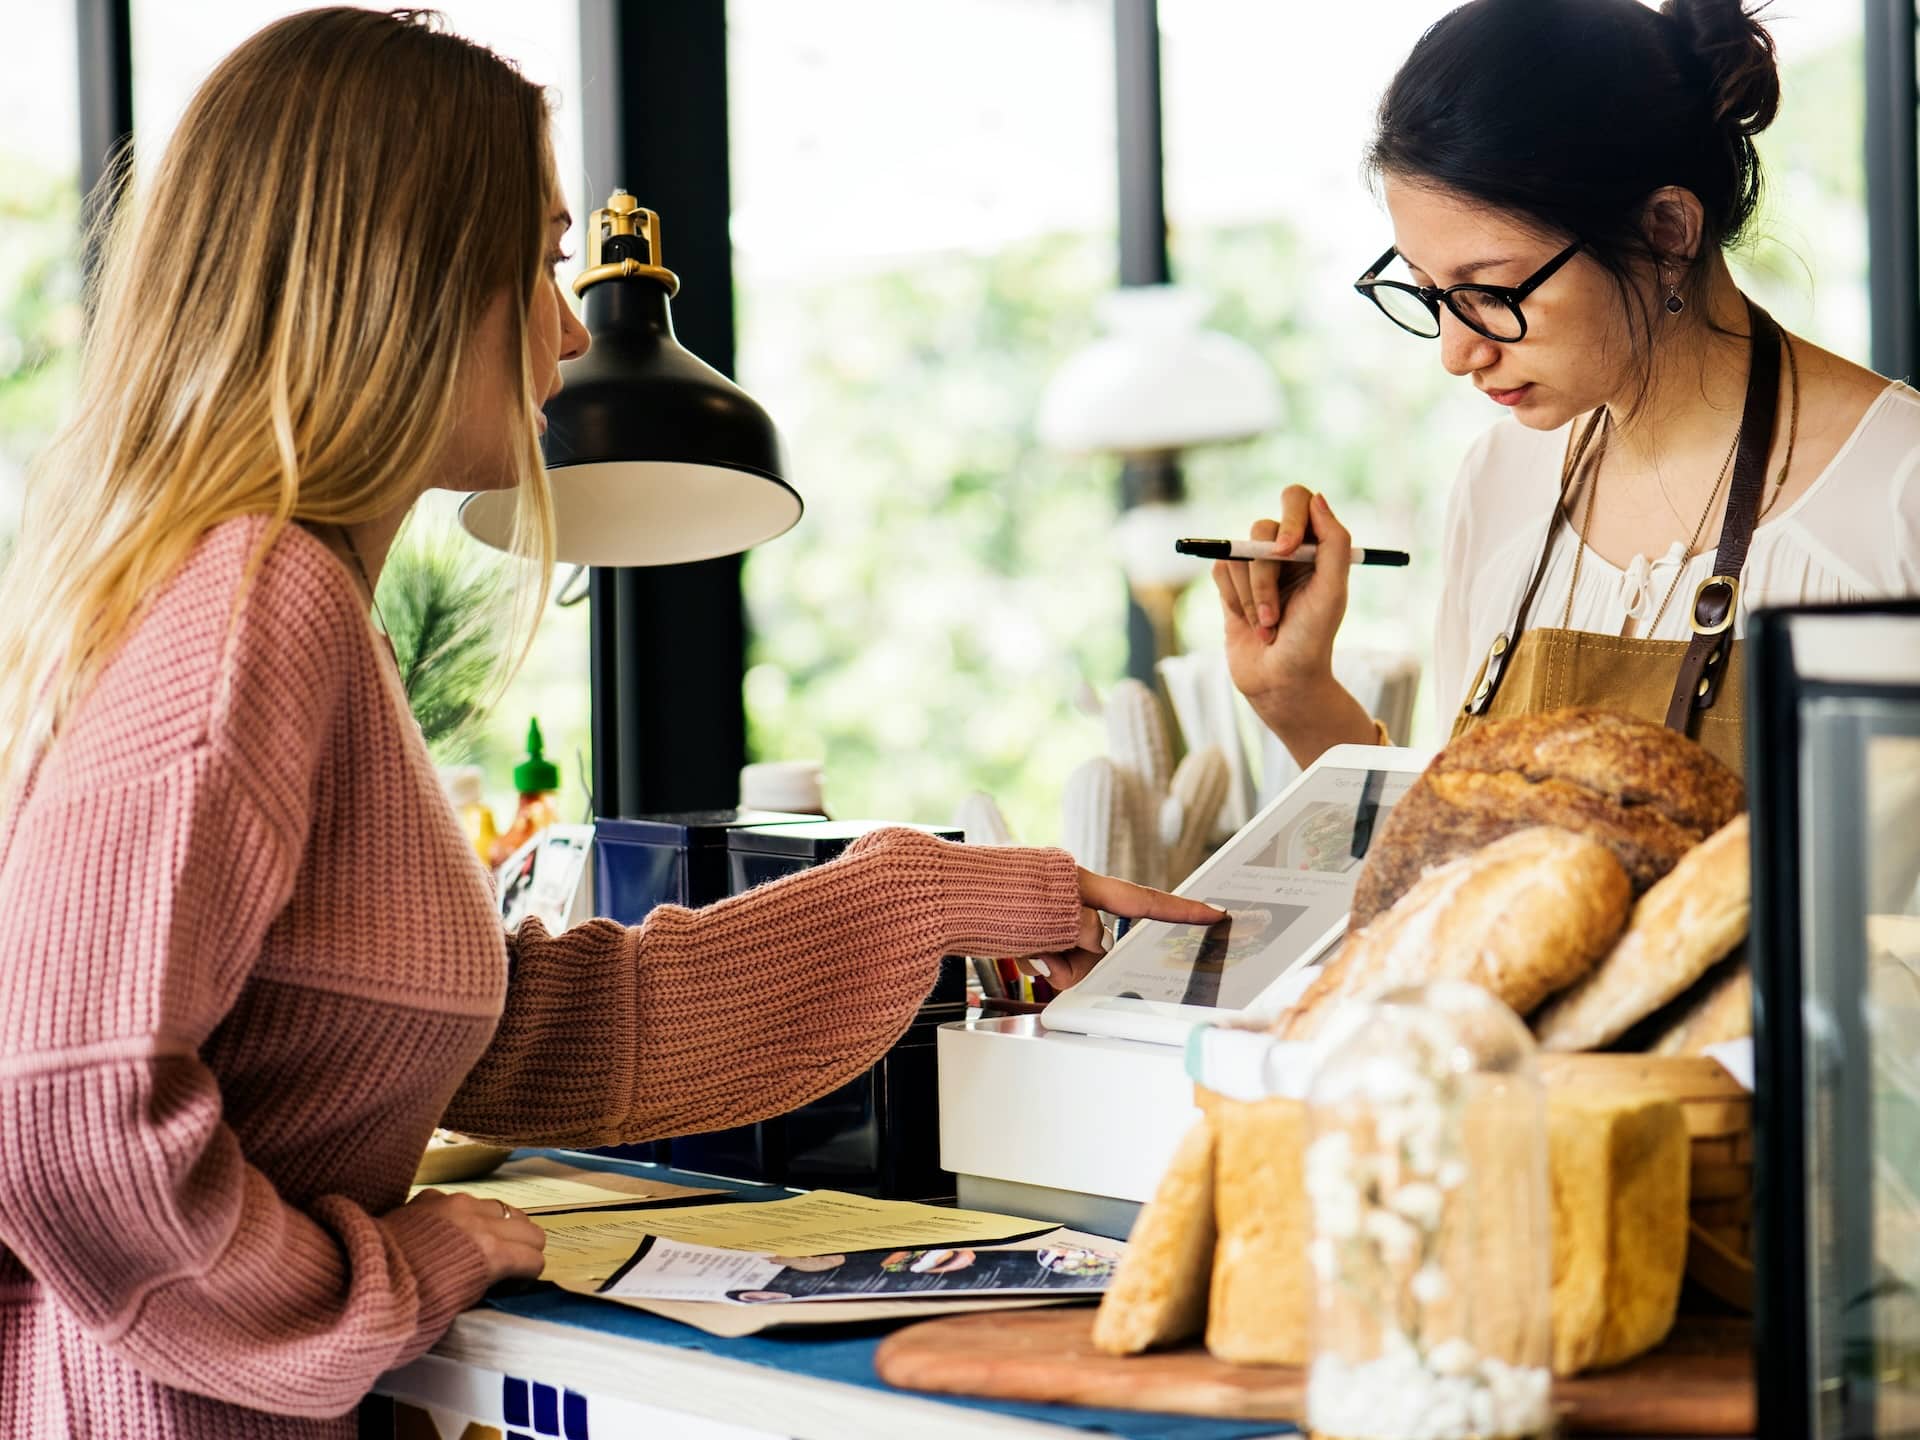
534 1190 1048 1290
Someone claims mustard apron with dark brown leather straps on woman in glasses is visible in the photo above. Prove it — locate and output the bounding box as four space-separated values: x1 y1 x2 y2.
1453 300 1780 772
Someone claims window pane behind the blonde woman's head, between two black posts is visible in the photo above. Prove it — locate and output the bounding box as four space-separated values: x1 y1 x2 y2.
132 0 605 824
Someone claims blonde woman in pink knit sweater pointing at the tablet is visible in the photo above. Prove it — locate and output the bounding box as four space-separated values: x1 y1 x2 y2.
0 10 1215 1440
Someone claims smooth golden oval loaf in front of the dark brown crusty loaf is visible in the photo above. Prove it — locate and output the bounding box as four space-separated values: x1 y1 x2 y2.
1279 826 1632 1041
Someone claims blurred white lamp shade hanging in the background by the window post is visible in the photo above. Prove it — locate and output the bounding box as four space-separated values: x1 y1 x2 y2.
1039 284 1281 453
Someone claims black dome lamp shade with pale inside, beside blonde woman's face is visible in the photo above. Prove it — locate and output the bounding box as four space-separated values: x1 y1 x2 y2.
461 210 801 566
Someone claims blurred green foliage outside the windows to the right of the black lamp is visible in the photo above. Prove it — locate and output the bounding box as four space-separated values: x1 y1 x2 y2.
739 40 1864 843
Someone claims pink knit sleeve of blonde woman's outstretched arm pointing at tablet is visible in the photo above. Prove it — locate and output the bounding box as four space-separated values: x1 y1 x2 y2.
445 829 1079 1146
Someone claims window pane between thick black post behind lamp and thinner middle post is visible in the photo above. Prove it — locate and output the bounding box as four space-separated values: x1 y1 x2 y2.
728 0 1125 841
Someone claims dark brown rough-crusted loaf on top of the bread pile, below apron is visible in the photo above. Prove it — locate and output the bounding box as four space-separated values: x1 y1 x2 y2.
1352 710 1745 929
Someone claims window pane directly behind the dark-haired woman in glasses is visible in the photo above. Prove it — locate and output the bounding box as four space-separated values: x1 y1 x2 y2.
1160 0 1868 743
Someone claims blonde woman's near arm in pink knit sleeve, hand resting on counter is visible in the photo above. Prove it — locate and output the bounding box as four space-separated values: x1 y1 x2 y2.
0 529 486 1417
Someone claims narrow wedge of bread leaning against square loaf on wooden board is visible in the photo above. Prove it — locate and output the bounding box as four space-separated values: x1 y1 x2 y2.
1092 1117 1215 1356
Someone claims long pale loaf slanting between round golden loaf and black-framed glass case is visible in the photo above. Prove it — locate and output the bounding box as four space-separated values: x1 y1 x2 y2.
1534 816 1751 1050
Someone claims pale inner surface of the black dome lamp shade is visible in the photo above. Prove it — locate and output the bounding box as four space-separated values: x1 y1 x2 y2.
461 461 801 564
